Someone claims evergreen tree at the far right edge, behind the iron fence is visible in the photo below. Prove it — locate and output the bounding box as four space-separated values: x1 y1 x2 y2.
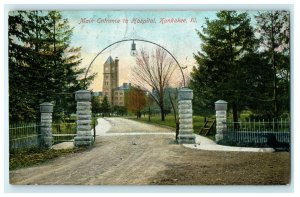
255 10 290 118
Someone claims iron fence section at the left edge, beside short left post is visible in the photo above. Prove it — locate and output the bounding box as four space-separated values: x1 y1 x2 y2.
9 123 41 149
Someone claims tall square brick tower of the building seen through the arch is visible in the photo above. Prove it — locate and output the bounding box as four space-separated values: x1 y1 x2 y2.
102 56 119 105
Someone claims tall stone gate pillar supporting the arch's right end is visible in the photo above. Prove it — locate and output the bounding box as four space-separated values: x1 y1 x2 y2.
178 88 195 144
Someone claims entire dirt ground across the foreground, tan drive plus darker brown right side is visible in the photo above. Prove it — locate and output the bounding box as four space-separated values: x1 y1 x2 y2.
10 118 290 185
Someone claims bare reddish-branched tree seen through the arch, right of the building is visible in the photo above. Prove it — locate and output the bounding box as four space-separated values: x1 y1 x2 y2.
132 47 176 121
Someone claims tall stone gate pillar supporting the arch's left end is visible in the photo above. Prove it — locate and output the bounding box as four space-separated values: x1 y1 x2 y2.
74 90 94 146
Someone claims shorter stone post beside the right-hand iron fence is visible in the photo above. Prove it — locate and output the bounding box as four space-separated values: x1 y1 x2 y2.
215 100 227 142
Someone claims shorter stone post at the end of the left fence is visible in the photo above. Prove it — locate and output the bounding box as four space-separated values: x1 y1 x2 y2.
40 102 53 149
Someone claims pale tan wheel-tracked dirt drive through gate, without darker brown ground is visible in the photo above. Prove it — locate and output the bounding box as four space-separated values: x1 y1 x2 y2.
10 118 178 185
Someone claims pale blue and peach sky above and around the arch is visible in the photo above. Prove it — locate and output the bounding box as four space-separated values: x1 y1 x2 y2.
62 10 255 91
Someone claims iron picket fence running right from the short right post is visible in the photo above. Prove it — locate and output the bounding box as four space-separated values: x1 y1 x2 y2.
223 119 290 146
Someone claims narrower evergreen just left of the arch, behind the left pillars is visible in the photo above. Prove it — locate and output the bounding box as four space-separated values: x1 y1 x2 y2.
47 11 89 119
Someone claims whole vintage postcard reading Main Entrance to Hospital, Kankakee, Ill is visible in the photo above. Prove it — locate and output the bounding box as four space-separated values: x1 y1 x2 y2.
8 9 291 185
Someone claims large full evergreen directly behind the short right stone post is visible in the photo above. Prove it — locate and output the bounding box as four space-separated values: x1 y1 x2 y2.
190 11 256 121
